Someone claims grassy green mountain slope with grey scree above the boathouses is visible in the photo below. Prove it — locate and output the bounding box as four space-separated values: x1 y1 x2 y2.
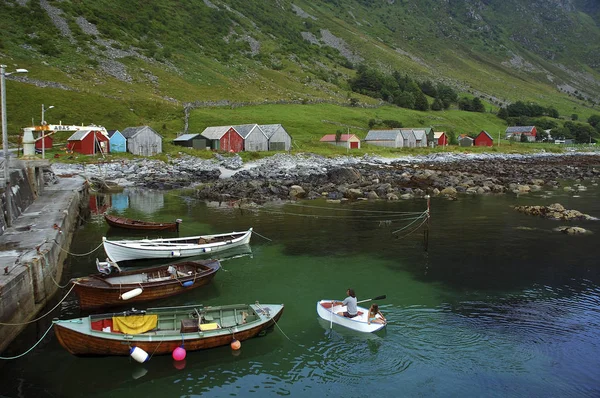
0 0 600 134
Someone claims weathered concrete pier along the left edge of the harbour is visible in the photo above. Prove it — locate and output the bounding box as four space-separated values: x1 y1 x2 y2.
0 160 89 352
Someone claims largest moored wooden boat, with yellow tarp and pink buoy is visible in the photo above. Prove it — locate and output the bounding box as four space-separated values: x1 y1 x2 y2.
53 302 284 360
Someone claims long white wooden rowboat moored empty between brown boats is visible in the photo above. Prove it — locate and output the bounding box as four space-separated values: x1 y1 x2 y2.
102 228 252 263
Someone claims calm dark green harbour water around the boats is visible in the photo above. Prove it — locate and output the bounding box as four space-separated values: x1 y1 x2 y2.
0 186 600 397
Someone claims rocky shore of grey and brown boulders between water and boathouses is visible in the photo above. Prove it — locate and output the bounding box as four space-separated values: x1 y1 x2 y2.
52 153 600 204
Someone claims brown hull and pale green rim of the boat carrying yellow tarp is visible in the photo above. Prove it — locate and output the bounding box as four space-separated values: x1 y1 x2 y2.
53 304 284 356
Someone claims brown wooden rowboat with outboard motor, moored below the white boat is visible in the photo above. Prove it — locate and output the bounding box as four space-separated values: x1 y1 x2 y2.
71 259 221 310
